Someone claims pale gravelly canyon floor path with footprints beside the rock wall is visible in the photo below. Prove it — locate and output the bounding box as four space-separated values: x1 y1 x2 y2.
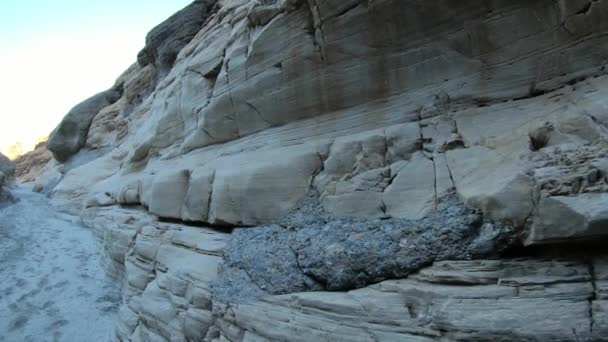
0 189 120 342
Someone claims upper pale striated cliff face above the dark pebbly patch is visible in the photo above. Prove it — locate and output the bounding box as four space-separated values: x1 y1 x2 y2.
45 1 606 238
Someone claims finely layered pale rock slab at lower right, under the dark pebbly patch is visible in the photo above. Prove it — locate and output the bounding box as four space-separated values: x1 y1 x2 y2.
207 259 605 341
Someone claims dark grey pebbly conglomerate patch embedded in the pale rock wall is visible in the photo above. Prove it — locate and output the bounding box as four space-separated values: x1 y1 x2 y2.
217 195 516 300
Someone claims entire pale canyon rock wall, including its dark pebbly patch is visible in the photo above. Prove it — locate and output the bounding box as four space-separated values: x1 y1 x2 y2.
25 0 608 341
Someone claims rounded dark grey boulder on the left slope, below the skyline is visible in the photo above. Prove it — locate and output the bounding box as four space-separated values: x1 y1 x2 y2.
47 89 121 162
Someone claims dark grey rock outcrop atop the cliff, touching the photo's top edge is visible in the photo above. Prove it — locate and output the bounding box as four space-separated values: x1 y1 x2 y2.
137 0 216 76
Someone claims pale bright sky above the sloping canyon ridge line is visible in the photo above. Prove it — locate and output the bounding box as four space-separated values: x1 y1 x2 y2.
0 0 192 156
